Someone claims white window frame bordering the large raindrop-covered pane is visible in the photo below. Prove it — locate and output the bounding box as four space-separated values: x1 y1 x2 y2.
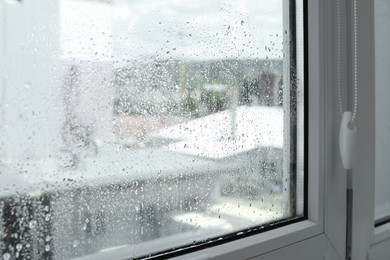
172 0 347 260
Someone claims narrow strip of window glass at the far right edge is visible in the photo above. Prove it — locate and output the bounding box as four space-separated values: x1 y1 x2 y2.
374 0 390 224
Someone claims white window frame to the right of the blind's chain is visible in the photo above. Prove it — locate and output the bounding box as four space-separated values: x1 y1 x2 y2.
350 0 390 260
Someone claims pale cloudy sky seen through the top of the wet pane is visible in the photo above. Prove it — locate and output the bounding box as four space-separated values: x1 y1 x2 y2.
60 0 283 64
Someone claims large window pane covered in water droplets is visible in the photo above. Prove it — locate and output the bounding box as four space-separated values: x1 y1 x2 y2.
0 0 304 260
